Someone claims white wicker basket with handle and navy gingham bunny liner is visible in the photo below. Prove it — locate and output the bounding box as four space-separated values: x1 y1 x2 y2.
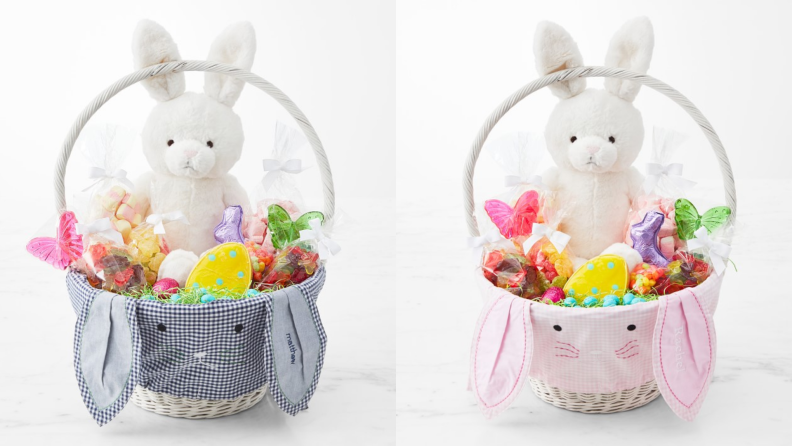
55 61 335 425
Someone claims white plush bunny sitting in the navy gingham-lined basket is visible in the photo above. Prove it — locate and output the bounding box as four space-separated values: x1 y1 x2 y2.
132 20 256 254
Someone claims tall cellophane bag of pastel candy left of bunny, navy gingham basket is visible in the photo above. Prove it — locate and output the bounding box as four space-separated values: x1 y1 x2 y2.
77 124 146 243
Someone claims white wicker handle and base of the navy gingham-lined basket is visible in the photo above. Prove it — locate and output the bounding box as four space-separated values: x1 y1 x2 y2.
55 61 335 419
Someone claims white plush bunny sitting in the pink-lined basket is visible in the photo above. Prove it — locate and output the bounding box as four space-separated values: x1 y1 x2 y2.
534 17 654 268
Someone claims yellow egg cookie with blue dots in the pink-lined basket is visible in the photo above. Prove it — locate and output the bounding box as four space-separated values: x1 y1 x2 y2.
564 254 630 299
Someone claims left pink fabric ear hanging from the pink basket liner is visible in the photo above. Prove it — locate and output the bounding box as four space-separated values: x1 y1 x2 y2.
469 291 533 418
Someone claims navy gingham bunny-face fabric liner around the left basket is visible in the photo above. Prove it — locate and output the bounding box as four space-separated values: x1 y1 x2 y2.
66 268 327 425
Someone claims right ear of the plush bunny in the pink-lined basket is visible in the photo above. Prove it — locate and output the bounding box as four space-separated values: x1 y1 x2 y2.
605 17 654 102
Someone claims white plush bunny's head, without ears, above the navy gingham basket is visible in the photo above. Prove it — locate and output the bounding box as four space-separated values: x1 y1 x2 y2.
143 92 245 178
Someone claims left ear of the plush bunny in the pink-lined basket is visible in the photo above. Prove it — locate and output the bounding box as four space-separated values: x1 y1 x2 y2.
534 22 586 99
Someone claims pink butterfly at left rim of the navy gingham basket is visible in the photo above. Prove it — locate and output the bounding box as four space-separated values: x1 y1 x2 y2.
27 211 83 269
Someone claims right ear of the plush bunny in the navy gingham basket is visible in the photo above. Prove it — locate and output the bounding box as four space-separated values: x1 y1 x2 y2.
204 22 256 107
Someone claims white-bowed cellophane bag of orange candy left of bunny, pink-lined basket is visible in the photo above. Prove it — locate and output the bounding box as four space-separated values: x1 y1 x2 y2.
523 194 574 293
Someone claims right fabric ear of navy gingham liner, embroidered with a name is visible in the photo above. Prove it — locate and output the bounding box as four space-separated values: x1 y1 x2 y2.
267 269 327 415
